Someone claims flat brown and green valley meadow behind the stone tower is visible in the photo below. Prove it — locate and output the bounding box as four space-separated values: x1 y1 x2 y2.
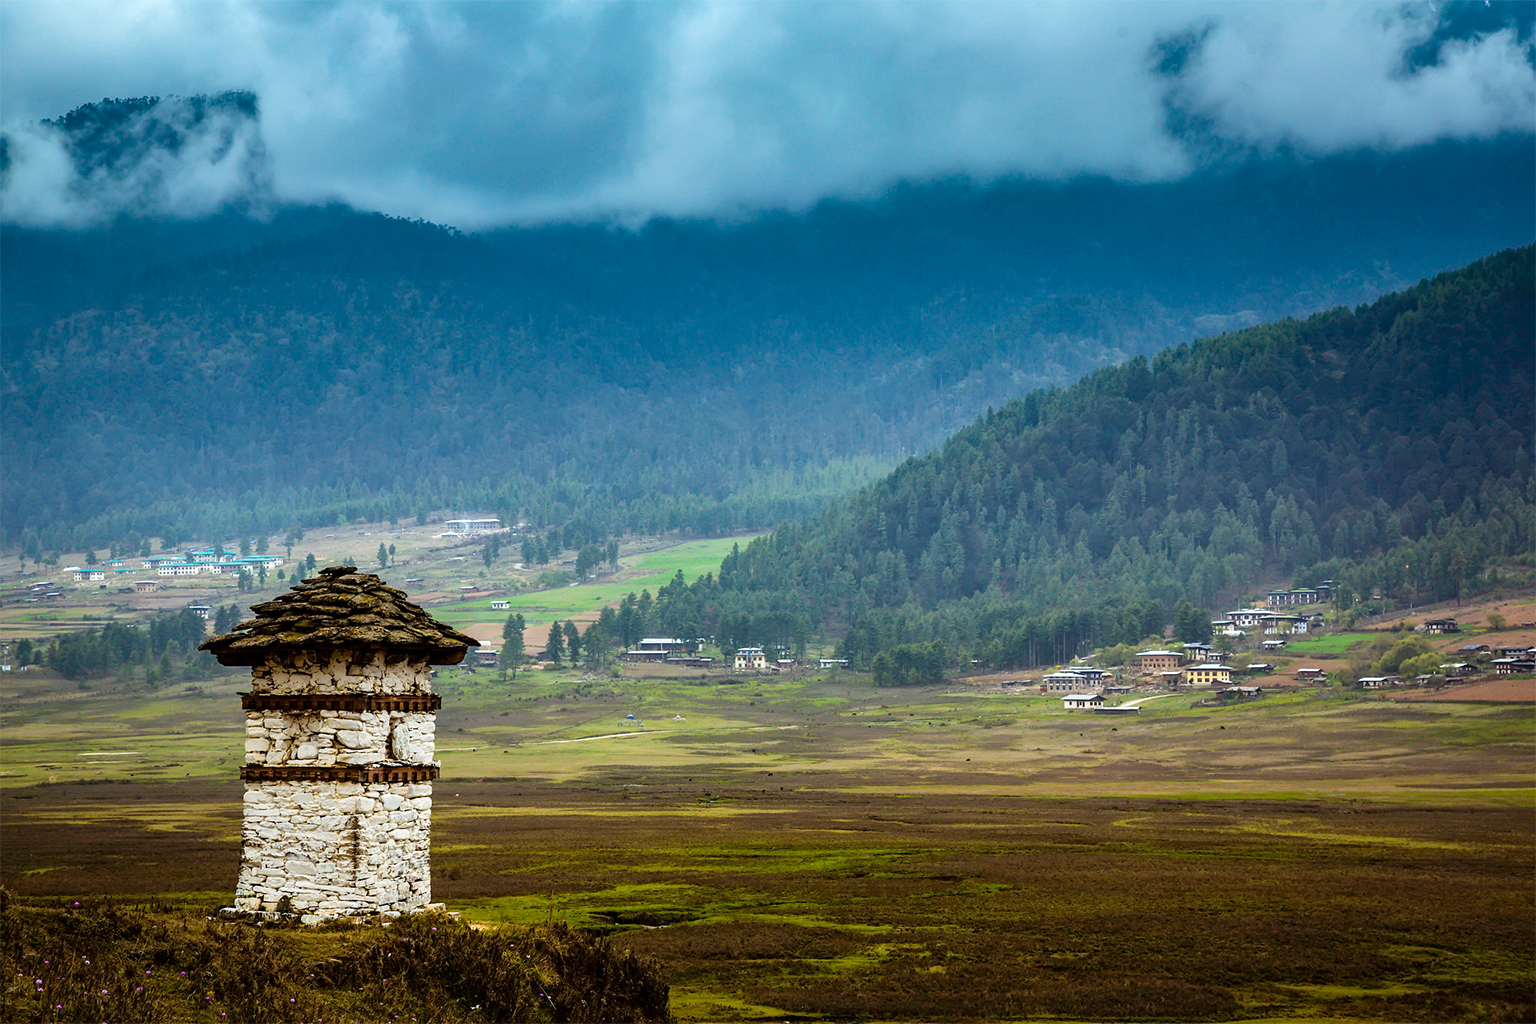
0 657 1536 1021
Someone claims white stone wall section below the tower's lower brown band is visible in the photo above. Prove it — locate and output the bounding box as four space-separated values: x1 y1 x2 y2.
235 781 432 924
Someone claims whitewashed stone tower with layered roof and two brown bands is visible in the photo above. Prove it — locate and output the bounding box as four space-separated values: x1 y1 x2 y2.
203 565 479 924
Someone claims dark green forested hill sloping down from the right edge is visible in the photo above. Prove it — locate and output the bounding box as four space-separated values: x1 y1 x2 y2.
719 247 1536 663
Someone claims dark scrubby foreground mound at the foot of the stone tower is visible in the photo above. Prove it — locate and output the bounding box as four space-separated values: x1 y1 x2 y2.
0 890 671 1024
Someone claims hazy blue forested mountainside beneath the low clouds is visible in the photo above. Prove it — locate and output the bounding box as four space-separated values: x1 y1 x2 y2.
0 94 1536 551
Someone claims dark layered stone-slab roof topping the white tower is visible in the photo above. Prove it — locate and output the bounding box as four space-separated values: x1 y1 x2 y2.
198 565 479 665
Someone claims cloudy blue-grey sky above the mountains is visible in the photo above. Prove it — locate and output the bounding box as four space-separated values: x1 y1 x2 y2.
0 0 1536 229
